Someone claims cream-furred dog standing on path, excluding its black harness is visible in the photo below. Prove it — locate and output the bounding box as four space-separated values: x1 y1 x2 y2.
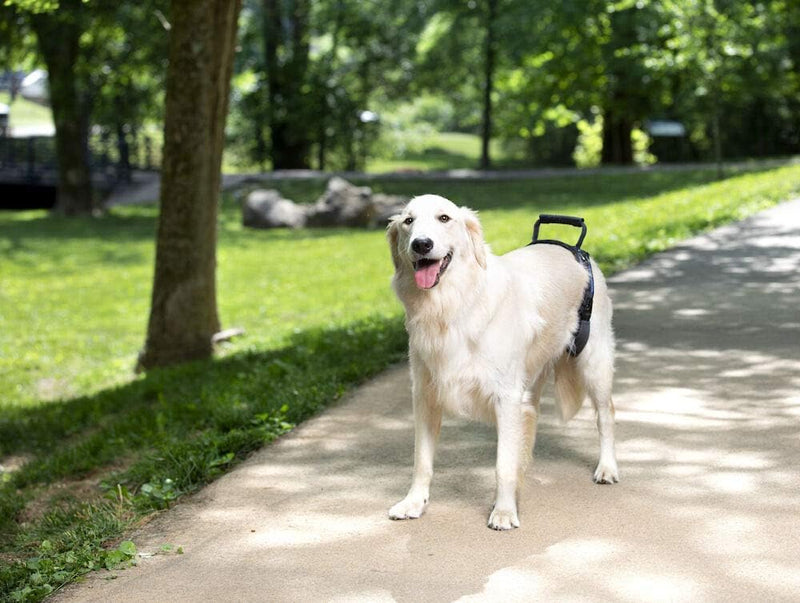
387 195 619 530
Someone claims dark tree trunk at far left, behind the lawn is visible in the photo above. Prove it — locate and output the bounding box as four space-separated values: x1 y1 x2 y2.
31 0 93 216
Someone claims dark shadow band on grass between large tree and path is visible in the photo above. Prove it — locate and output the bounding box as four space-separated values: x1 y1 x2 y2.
0 317 406 531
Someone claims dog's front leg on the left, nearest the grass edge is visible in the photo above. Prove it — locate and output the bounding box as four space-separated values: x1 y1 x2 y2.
389 388 442 519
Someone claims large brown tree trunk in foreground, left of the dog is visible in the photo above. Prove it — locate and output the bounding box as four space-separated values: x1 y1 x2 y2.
139 0 241 369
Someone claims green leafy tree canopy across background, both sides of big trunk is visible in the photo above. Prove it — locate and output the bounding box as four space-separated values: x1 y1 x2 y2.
0 0 800 196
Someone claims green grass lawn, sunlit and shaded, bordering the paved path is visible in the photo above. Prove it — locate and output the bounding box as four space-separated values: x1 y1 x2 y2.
0 160 800 600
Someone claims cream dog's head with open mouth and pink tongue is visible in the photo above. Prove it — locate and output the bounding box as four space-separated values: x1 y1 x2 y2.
387 195 486 289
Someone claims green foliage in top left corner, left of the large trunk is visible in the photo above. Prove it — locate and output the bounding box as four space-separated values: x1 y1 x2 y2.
0 0 168 180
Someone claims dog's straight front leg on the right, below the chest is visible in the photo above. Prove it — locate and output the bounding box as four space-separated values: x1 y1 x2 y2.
488 402 525 530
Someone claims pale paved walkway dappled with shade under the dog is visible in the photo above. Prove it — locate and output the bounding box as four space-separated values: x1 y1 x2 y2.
55 200 800 603
